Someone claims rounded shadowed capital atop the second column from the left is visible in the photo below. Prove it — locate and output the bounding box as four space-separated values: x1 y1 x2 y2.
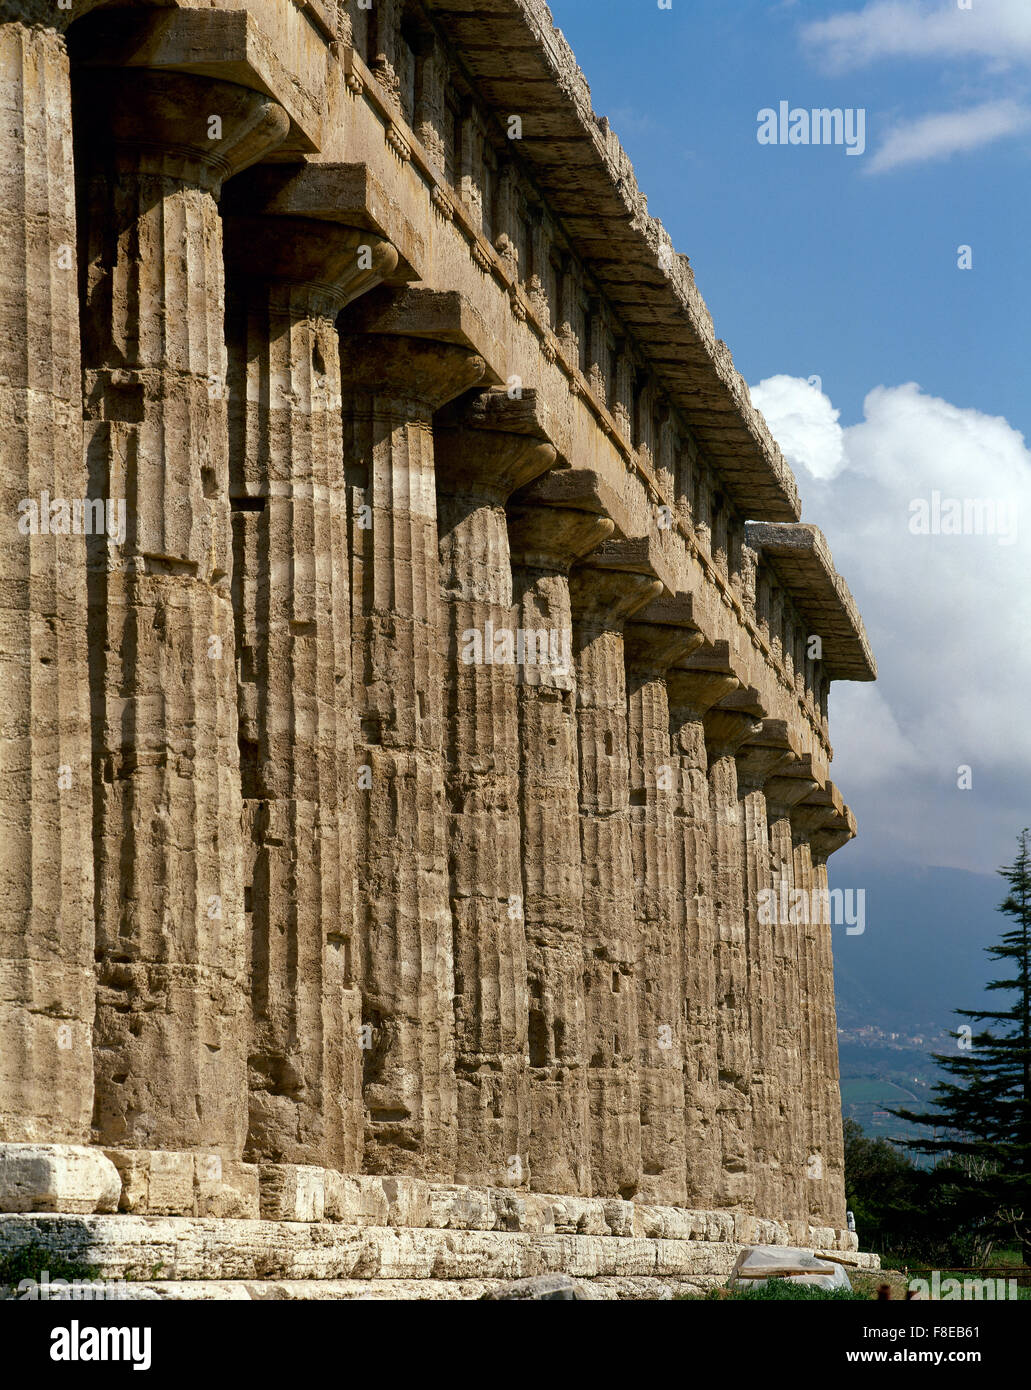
72 68 290 196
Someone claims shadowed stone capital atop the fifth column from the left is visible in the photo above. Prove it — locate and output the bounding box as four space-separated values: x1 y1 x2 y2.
434 386 559 506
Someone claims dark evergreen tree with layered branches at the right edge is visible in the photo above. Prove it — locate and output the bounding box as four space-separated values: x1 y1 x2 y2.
891 830 1031 1264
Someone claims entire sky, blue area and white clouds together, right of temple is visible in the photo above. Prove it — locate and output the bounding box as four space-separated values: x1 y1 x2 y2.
552 0 1031 873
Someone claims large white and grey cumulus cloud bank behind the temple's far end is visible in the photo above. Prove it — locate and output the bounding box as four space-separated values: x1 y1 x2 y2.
752 377 1031 872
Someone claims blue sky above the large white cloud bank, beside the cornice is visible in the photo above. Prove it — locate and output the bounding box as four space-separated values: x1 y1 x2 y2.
552 0 1031 432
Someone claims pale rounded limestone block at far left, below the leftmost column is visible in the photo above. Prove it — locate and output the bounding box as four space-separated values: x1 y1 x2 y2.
0 1143 121 1212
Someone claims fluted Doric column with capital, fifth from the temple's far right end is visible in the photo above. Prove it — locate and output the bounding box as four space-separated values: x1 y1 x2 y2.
704 689 763 1209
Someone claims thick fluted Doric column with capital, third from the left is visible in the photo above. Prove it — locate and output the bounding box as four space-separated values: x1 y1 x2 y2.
222 164 397 1172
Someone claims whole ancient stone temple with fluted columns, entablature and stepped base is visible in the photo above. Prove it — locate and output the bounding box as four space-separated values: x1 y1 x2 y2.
0 0 875 1297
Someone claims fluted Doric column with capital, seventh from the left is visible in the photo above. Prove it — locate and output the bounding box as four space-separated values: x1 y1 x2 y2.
570 541 663 1198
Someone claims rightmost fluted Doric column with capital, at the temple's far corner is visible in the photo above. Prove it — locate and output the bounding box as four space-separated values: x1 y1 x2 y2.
810 783 856 1230
